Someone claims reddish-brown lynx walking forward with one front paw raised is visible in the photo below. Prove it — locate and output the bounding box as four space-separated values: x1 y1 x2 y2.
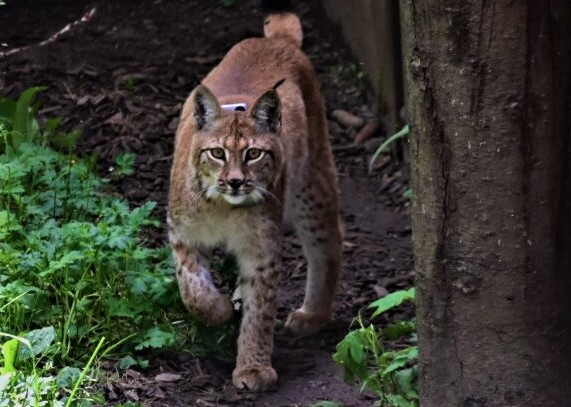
168 13 342 391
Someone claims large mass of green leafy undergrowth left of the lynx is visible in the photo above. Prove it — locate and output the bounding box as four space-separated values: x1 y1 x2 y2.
0 88 239 407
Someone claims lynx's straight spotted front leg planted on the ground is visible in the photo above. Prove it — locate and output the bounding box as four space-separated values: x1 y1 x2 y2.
232 252 279 391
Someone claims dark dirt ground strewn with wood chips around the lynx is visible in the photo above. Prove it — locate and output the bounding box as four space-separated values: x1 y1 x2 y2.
0 0 413 406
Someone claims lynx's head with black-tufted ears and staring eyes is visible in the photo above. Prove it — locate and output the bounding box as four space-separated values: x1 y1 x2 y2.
188 85 283 206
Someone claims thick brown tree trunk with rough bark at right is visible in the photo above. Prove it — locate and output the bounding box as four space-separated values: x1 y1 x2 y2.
402 0 571 407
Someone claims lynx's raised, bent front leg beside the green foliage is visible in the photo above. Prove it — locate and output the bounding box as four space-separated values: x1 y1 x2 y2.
171 234 233 326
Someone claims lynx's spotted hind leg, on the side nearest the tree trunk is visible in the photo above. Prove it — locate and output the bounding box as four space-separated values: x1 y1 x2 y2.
286 180 342 335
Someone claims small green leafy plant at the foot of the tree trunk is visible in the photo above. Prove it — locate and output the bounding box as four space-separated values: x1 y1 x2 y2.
333 288 419 407
